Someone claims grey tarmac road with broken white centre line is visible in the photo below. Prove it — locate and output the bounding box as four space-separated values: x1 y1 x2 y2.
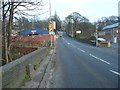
54 33 120 88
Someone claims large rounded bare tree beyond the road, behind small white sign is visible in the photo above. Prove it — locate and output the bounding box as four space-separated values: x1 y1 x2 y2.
65 12 95 39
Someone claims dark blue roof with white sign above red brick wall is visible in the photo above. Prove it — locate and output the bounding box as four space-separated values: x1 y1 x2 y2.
18 28 48 36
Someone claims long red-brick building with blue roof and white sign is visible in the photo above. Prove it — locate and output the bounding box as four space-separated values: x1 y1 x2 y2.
16 28 55 45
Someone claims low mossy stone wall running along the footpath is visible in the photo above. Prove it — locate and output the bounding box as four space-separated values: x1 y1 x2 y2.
0 48 48 89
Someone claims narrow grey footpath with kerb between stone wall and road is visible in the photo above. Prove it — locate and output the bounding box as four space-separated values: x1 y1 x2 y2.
21 48 55 89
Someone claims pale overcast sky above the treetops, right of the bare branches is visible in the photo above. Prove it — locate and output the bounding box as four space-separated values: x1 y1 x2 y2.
41 0 120 22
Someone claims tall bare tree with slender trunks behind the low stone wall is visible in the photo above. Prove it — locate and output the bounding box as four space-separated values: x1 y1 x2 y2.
0 0 43 63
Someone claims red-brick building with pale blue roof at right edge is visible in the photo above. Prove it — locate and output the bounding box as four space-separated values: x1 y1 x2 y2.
99 23 120 43
